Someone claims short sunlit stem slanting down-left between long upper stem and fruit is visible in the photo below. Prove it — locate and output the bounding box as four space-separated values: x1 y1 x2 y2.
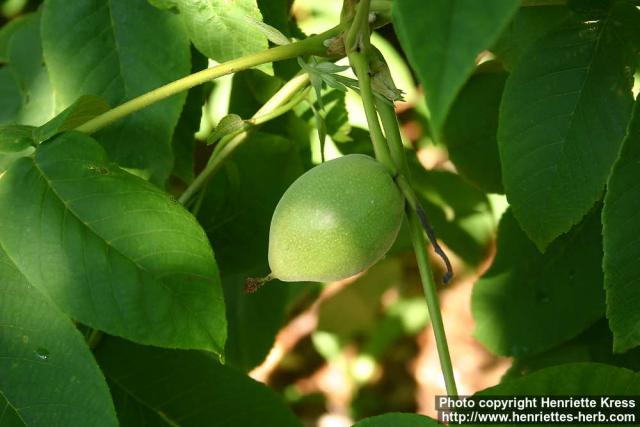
178 74 309 205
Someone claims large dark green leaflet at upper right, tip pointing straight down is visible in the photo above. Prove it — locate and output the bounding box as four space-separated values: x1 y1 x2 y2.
498 3 640 251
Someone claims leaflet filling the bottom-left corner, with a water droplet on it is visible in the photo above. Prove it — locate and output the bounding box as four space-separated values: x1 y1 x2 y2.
0 247 118 427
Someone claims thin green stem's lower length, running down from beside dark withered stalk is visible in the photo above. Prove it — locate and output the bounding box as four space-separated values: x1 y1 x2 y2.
407 212 458 396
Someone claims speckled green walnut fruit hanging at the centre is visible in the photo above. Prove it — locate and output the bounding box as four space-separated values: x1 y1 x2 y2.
269 154 404 282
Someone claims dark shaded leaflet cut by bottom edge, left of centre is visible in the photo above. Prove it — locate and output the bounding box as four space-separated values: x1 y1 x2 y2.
96 337 301 427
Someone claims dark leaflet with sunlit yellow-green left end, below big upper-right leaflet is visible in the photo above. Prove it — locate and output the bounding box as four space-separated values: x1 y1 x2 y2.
472 210 604 357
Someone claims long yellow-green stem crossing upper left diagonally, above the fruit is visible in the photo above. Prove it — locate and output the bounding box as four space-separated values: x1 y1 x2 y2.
76 27 341 134
